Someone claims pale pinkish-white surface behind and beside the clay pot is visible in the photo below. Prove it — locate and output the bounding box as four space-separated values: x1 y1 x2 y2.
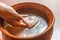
0 0 60 40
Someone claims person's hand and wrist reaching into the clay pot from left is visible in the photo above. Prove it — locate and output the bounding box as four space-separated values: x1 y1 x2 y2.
0 2 29 27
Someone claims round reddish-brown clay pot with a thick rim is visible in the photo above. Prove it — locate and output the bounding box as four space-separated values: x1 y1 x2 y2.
0 2 54 40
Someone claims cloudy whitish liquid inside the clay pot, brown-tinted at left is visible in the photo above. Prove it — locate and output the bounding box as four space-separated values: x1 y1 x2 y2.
5 15 48 37
